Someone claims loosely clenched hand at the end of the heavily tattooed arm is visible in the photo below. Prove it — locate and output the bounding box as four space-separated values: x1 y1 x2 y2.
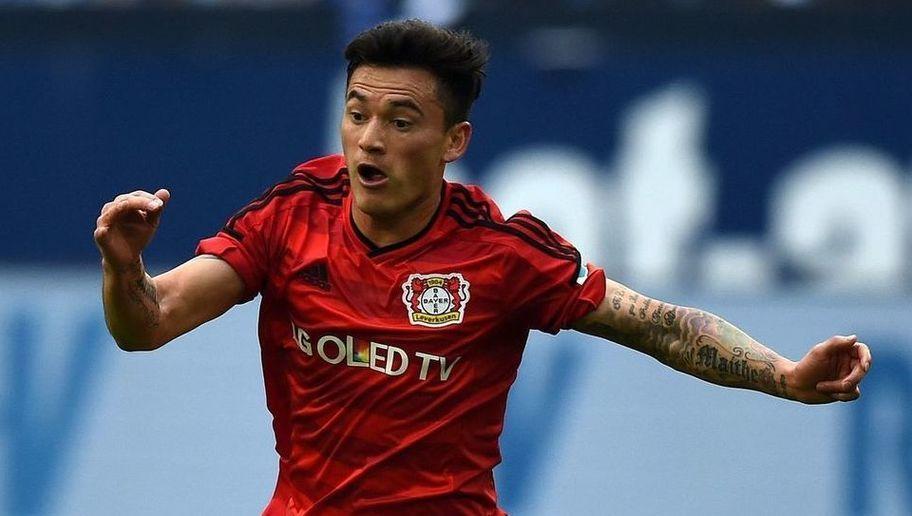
789 335 871 403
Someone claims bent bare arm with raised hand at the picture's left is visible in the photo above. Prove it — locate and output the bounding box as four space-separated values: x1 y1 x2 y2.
95 190 244 351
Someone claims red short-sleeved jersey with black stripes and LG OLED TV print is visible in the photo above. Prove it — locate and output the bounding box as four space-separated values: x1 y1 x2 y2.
197 156 605 515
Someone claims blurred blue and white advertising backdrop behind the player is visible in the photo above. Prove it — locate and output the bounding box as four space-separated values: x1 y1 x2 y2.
0 0 912 515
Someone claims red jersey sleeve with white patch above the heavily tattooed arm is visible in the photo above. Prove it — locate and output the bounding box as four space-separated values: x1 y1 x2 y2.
507 212 605 334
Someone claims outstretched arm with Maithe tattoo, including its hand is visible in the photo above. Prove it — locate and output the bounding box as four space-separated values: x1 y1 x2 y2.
573 280 871 403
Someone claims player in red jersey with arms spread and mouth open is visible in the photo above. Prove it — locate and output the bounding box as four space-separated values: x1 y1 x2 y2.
95 21 871 515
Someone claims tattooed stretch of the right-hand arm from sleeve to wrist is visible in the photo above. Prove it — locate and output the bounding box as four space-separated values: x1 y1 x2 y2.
594 289 787 397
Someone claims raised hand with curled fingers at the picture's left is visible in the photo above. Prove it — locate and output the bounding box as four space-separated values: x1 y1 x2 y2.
95 189 171 270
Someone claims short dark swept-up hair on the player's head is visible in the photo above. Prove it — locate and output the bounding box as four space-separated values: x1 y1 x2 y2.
345 20 488 127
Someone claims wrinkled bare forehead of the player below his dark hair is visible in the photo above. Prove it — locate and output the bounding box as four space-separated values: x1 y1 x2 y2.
347 65 439 104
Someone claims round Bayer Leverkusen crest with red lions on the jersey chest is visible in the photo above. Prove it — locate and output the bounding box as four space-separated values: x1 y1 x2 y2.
402 272 469 328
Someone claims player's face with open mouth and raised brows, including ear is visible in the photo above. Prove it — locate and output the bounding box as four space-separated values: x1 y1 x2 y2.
341 65 471 221
